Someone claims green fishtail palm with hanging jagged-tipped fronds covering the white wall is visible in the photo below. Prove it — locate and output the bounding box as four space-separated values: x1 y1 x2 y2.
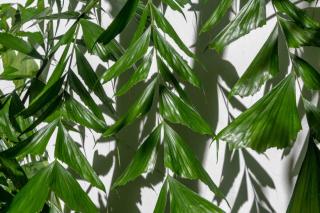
0 0 320 212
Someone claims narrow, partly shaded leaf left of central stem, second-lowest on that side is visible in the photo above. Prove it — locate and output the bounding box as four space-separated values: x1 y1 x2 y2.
103 78 158 137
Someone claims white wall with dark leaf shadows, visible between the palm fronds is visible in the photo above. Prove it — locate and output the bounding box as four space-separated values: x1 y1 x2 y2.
0 0 319 213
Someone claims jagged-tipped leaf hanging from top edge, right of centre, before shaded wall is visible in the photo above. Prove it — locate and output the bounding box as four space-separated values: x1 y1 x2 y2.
200 0 233 32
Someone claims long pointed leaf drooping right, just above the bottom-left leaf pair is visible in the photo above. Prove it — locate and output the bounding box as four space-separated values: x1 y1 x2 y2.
54 122 105 190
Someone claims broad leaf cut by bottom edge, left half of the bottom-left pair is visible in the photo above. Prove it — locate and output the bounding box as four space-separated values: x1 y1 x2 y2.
8 164 54 213
